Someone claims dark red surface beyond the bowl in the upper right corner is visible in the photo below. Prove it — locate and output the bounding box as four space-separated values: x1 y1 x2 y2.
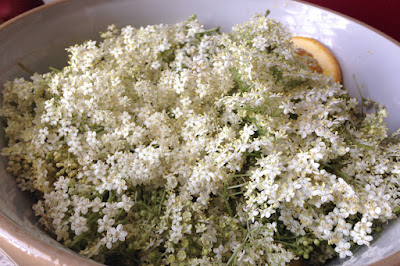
303 0 400 41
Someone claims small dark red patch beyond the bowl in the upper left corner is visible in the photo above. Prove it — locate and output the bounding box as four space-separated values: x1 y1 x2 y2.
0 0 44 22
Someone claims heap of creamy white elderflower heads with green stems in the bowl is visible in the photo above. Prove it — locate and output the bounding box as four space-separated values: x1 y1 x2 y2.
2 14 400 265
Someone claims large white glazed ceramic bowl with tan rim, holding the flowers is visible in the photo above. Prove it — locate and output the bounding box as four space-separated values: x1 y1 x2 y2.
0 0 400 265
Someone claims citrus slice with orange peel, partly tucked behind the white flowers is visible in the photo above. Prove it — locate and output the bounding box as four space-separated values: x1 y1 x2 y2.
292 36 342 83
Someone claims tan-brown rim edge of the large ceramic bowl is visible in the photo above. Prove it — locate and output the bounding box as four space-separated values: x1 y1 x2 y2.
0 0 400 266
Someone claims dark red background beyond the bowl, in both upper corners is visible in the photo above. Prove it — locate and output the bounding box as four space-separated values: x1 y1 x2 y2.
0 0 400 41
